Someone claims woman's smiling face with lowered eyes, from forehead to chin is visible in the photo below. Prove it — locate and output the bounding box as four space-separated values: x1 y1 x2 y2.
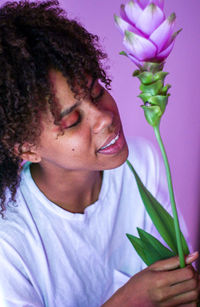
34 70 128 176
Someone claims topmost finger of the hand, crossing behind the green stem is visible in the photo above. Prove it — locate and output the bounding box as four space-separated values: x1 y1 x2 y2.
149 252 199 271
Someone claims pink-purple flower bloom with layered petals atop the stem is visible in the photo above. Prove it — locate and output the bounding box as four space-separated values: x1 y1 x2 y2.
115 0 180 67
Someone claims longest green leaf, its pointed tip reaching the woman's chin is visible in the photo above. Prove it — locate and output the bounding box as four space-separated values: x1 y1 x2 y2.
127 160 189 255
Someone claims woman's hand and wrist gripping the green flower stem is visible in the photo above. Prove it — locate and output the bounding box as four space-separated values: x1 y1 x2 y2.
102 252 199 307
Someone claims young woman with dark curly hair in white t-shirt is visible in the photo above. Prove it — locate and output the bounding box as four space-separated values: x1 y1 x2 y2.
0 1 199 307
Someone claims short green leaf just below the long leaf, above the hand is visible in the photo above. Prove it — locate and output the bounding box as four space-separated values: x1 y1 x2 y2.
137 228 175 262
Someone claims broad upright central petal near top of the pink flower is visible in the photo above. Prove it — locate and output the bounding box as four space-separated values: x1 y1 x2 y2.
136 3 165 35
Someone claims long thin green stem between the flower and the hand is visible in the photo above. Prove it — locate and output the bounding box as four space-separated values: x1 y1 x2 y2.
154 124 185 268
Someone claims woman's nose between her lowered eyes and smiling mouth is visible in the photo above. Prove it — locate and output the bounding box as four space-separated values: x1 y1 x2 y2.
90 106 114 134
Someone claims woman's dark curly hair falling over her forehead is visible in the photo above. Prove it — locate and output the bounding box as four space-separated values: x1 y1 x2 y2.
0 0 111 215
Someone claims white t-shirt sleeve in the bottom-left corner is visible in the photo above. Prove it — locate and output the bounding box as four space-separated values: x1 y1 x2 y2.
0 239 44 307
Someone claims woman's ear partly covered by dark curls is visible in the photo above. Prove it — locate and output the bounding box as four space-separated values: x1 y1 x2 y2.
14 143 41 163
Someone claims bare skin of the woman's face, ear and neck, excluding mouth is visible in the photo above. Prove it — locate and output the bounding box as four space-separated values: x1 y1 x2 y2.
22 70 128 213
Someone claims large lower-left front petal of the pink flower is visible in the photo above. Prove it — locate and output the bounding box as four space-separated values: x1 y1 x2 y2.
123 31 157 61
